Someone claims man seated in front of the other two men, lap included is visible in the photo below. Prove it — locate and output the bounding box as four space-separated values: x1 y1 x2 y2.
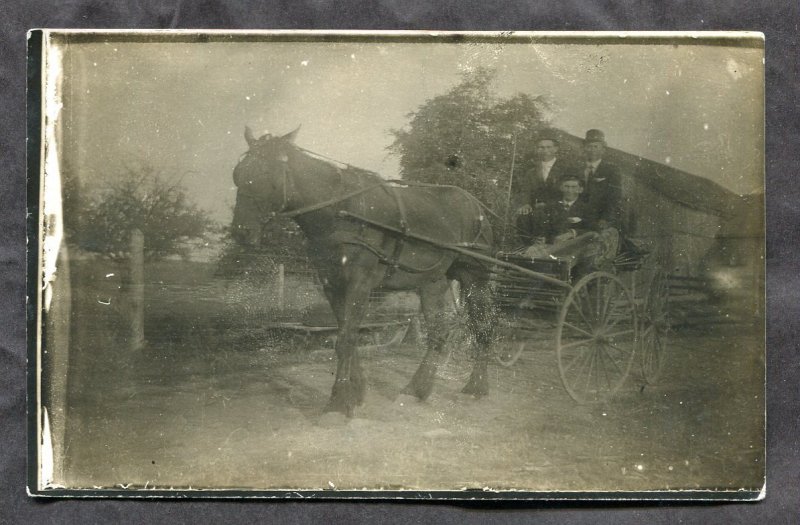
521 175 619 276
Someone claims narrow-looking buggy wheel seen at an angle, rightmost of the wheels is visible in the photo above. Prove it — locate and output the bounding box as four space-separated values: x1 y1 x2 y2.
640 268 669 384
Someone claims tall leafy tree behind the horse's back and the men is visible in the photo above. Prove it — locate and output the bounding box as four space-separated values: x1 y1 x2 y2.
389 68 552 217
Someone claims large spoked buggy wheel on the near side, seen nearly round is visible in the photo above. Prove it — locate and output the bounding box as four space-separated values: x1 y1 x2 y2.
556 272 638 403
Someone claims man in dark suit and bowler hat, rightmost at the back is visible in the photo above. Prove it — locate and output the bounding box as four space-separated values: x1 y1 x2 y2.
582 129 622 231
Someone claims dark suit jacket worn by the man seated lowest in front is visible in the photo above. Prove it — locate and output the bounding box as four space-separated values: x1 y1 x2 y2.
520 199 592 245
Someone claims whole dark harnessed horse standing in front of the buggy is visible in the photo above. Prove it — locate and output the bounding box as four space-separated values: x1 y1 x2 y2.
232 127 494 417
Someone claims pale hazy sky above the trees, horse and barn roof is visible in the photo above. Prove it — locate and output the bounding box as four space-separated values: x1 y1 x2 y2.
56 35 764 222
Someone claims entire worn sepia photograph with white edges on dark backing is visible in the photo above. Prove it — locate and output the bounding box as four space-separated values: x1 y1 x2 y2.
28 30 765 499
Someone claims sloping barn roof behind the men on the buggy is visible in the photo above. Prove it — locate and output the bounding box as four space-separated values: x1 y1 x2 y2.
561 132 741 215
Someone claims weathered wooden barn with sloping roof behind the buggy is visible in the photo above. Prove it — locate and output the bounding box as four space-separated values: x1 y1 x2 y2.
528 132 765 320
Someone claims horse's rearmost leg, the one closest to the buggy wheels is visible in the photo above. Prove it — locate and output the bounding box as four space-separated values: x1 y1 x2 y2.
461 279 497 397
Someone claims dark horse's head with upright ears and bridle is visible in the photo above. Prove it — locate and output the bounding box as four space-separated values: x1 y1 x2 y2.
233 127 300 245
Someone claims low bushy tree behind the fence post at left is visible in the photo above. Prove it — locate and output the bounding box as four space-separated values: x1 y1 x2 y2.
77 164 214 259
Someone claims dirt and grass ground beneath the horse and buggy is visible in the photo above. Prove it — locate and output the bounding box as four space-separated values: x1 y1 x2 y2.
56 265 764 491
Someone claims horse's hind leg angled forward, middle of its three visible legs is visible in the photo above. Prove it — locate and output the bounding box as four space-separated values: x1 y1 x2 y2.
403 278 450 401
